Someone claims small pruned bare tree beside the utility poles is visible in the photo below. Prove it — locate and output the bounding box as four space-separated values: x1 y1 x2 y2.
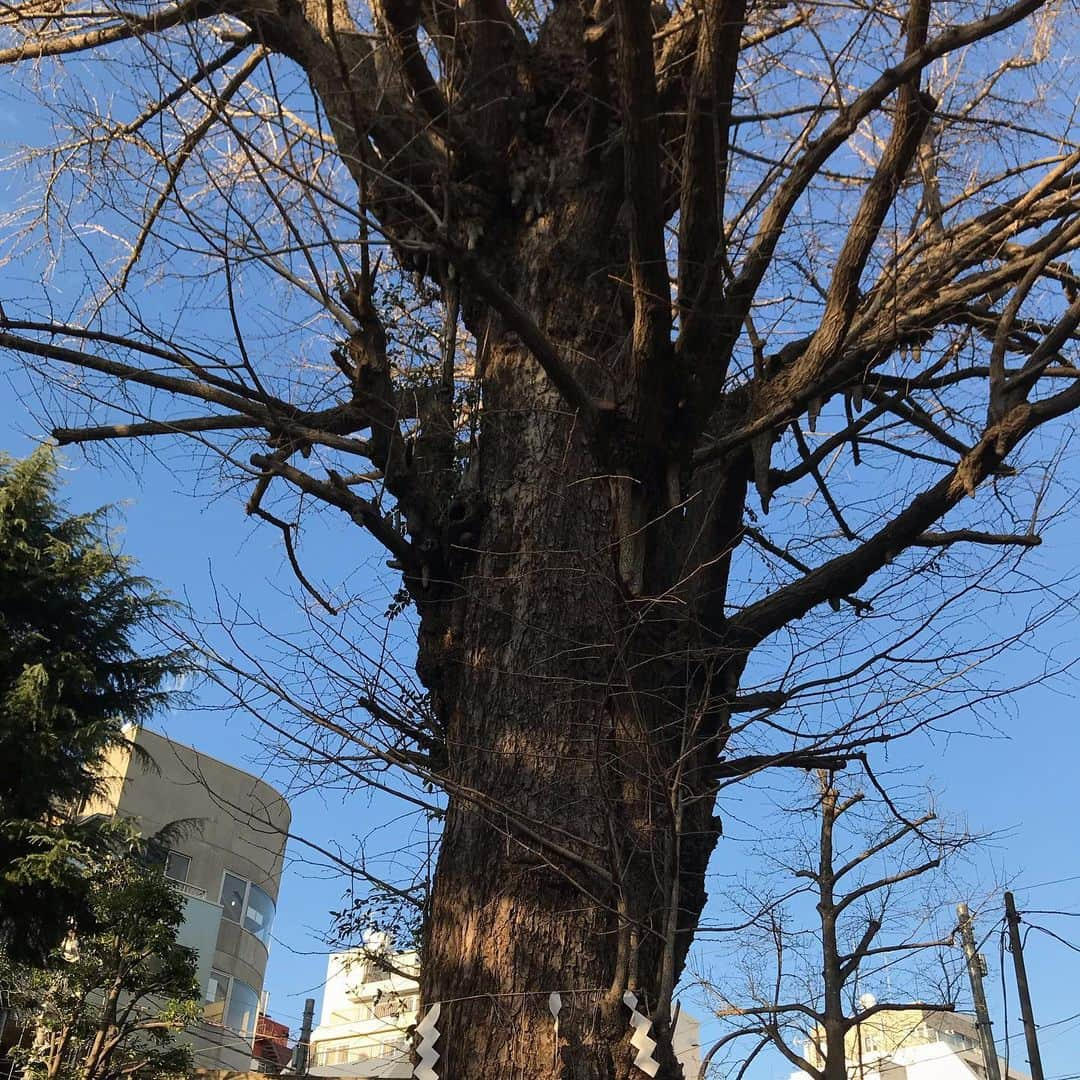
702 770 977 1080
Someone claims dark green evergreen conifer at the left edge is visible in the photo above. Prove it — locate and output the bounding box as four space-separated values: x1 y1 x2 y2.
0 448 184 960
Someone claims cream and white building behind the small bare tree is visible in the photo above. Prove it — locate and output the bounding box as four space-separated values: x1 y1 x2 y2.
792 999 1029 1080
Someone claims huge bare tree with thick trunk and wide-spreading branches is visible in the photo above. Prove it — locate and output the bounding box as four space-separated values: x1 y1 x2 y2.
0 0 1080 1080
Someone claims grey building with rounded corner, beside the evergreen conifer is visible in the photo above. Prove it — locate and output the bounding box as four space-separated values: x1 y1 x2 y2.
85 728 291 1069
